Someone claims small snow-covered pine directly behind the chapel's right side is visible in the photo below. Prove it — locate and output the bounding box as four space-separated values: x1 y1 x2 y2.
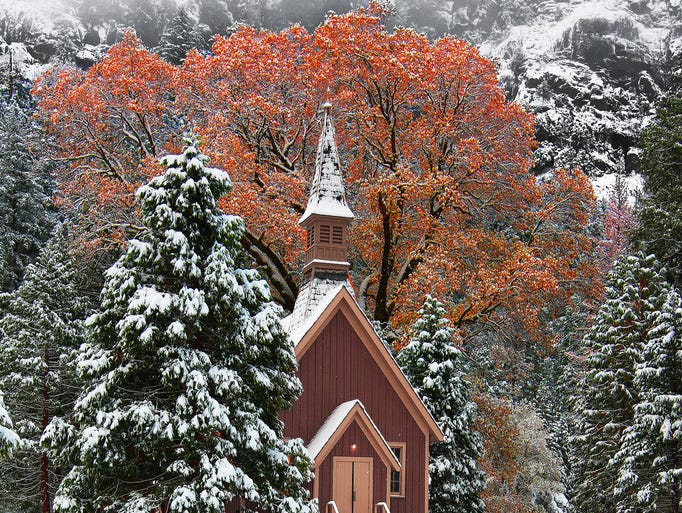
397 296 485 513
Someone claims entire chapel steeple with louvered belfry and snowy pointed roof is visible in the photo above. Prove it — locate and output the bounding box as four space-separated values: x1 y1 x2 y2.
290 102 355 329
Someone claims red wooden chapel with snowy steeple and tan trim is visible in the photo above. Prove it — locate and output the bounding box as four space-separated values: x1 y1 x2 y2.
281 103 443 513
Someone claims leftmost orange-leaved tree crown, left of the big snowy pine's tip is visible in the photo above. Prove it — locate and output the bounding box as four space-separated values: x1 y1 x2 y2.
32 33 179 247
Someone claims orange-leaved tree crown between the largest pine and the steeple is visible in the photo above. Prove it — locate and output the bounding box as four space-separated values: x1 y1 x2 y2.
177 27 322 309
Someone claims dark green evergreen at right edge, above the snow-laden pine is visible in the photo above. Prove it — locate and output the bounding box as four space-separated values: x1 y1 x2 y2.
633 55 682 288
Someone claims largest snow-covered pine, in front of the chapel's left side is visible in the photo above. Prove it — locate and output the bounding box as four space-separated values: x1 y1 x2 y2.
45 140 316 513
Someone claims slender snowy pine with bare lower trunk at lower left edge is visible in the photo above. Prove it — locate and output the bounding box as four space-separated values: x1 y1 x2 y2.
0 229 87 513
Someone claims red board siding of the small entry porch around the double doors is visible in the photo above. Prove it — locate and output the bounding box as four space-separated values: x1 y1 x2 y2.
317 422 388 512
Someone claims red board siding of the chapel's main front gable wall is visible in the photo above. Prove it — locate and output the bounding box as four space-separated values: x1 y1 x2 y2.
281 312 426 513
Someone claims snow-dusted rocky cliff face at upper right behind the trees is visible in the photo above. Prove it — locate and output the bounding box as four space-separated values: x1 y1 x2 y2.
397 0 682 186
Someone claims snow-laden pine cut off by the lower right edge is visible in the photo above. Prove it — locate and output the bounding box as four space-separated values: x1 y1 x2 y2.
614 284 682 513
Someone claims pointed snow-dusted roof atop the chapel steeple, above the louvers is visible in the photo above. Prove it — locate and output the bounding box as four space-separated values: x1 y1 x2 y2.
298 102 355 224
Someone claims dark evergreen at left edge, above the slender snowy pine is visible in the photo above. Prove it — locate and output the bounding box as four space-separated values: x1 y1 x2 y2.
0 103 54 292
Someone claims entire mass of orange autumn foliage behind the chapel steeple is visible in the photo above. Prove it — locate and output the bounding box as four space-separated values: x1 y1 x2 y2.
35 7 598 341
